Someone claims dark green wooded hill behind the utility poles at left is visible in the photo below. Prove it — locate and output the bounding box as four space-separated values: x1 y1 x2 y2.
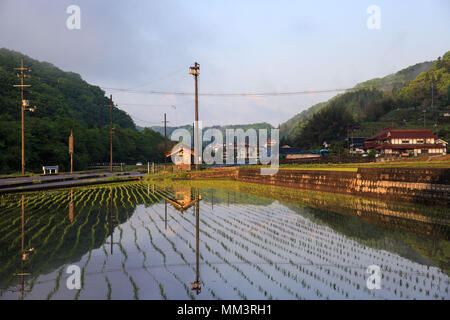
0 48 163 173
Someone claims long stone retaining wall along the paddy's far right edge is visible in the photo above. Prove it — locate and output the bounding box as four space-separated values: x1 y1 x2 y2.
189 168 450 206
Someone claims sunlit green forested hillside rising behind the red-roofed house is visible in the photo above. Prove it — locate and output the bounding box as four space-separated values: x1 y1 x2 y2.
280 52 450 148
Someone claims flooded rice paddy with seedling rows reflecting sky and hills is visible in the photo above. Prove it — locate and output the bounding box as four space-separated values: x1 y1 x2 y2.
0 183 450 300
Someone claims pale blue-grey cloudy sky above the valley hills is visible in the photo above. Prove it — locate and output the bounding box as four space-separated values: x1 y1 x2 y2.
0 0 450 126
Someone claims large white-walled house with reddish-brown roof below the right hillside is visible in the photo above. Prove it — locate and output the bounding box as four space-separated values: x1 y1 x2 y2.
364 129 448 156
